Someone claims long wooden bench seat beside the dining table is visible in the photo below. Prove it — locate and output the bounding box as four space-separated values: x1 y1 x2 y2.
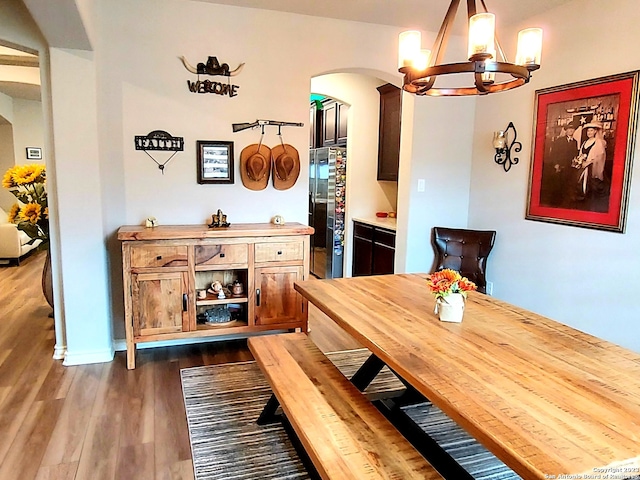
248 333 442 480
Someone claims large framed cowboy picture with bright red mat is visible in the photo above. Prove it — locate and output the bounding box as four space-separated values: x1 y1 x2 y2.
525 71 639 233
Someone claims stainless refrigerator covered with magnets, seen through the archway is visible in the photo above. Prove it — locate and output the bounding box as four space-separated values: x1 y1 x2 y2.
309 147 347 278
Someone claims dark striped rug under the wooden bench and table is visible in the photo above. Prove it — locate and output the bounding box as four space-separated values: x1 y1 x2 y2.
181 349 520 480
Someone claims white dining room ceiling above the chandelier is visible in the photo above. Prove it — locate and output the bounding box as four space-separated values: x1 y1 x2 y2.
198 0 573 34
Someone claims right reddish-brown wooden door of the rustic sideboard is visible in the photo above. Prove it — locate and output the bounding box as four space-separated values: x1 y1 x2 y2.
254 266 304 325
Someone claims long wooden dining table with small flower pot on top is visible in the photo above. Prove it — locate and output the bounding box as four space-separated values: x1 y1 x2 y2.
295 274 640 479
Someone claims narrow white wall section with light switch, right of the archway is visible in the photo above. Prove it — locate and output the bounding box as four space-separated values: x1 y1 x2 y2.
395 36 476 273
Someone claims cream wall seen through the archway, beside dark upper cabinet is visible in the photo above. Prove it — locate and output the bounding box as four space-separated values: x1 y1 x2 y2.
311 73 396 276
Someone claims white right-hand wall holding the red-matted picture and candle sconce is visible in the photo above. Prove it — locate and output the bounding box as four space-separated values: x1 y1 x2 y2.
469 0 640 351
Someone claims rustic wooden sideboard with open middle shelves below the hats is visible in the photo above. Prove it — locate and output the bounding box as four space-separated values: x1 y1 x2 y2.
118 223 313 369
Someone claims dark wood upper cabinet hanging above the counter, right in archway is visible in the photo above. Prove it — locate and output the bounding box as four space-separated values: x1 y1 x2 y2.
378 83 402 181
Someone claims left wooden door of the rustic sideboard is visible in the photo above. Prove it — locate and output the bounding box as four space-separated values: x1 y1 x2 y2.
132 272 189 337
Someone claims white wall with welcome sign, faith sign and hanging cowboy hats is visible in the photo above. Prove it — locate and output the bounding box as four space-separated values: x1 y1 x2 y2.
86 0 410 350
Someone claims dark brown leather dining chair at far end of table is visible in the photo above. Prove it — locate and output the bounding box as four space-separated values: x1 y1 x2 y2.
433 227 496 293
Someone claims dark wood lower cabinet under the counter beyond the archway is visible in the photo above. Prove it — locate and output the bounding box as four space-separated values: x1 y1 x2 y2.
352 222 396 277
